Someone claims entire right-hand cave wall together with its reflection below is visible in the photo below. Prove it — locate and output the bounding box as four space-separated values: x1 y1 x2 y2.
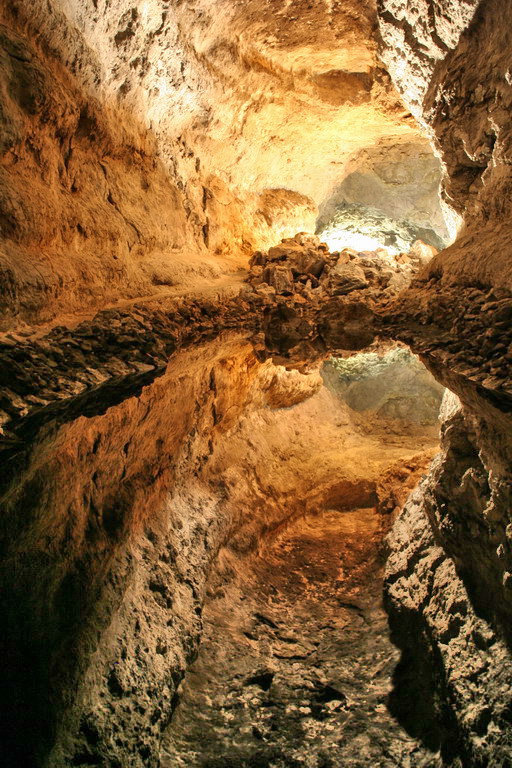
379 0 512 766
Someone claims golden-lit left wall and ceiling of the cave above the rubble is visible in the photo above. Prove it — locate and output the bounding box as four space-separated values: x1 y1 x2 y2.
0 0 428 328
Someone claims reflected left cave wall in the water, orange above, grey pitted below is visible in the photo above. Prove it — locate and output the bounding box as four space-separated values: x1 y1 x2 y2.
1 337 278 766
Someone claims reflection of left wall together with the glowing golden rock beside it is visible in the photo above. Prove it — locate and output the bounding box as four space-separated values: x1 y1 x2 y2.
0 337 440 768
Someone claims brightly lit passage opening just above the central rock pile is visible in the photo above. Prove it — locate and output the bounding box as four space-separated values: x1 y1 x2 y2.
315 139 456 257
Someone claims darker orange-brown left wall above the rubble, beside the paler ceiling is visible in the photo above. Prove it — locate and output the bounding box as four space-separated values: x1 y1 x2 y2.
0 15 226 328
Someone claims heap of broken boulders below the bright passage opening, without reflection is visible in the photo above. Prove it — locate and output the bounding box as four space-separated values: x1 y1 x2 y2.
249 232 435 304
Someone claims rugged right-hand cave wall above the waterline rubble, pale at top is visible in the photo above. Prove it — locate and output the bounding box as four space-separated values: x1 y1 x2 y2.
379 0 512 292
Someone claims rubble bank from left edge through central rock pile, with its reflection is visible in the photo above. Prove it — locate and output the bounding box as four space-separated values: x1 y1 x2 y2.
0 234 442 451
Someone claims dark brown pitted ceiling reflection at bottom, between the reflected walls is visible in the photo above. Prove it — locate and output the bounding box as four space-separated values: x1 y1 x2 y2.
161 509 440 768
